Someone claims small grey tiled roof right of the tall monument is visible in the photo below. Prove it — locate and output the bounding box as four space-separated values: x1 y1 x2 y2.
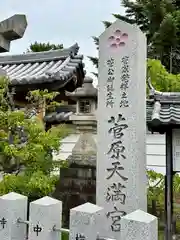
146 78 180 132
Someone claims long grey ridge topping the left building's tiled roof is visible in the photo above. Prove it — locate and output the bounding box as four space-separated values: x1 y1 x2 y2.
0 43 79 64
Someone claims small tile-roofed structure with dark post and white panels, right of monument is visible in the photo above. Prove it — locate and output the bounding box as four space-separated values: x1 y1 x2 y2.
146 79 180 173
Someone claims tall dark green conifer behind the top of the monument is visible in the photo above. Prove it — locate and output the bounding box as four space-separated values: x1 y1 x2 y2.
89 0 180 76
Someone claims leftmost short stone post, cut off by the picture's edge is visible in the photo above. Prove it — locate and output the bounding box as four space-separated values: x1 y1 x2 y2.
0 192 27 240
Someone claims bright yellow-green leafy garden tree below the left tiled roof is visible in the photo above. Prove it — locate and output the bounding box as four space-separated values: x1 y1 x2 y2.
0 77 68 197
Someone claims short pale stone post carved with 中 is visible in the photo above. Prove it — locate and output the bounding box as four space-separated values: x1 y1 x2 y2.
28 196 62 240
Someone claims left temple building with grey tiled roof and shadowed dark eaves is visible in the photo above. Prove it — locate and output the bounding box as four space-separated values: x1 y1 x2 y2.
0 44 85 123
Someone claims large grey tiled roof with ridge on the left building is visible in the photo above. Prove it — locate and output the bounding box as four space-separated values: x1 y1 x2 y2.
0 44 84 87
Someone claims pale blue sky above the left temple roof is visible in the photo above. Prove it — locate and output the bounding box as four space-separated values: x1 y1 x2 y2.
0 0 123 84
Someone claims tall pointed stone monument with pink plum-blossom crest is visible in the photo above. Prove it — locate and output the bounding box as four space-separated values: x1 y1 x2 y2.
96 20 147 240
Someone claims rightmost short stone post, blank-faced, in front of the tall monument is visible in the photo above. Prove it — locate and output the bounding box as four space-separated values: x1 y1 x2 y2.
121 210 158 240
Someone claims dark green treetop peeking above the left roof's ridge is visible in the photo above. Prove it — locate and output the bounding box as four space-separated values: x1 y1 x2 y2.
27 41 63 52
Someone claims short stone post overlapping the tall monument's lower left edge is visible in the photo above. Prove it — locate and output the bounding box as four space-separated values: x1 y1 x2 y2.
69 203 105 240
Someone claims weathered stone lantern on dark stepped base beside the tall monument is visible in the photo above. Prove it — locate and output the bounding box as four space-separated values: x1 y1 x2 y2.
54 77 97 226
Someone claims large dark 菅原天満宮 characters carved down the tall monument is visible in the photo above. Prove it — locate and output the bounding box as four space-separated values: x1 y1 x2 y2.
106 114 128 232
